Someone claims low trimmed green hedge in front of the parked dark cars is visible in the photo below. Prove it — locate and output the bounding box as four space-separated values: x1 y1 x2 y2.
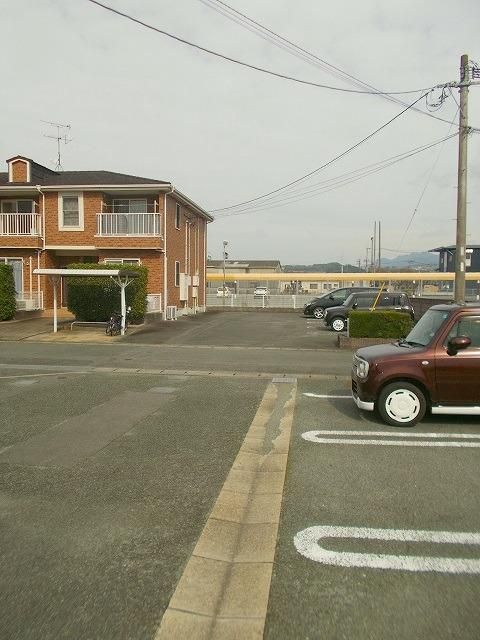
348 311 413 338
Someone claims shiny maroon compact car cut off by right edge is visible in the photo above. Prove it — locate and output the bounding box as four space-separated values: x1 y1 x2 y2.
352 303 480 427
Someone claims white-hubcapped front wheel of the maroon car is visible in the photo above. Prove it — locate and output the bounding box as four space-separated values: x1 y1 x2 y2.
377 382 427 427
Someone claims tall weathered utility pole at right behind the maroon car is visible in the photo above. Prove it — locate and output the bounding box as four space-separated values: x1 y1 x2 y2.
455 54 470 304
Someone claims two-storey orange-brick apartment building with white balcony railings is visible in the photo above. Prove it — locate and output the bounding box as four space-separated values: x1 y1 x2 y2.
0 156 213 317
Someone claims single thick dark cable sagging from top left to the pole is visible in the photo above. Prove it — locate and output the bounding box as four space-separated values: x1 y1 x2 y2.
87 0 436 95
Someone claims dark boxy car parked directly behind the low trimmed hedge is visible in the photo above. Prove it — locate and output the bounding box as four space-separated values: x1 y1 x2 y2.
325 291 415 332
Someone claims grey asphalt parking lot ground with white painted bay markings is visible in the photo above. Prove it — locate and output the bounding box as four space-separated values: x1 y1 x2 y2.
0 312 480 640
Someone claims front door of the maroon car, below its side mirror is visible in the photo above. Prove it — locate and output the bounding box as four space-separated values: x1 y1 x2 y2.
435 315 480 406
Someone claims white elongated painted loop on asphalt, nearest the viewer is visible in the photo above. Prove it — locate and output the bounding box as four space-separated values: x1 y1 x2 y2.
294 526 480 574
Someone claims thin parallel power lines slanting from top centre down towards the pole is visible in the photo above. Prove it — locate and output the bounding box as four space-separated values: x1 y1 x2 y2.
200 0 458 124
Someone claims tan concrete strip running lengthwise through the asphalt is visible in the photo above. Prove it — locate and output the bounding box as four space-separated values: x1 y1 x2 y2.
155 379 296 640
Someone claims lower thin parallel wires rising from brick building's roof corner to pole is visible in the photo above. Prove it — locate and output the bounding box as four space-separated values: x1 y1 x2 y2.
215 133 458 220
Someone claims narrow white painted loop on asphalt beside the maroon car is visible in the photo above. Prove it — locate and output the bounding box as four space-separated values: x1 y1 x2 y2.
302 430 480 449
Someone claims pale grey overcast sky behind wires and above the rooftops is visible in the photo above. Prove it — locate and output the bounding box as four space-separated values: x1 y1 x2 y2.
0 0 480 264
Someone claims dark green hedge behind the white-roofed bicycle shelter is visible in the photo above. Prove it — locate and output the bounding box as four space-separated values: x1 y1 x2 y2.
66 263 148 324
